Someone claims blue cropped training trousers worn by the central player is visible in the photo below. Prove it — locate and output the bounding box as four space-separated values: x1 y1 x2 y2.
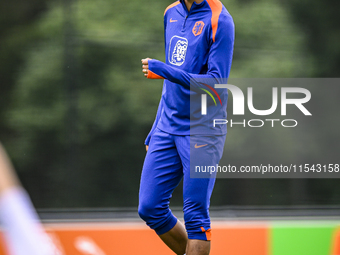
138 128 226 240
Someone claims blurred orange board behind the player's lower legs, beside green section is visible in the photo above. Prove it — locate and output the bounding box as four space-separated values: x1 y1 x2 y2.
0 222 270 255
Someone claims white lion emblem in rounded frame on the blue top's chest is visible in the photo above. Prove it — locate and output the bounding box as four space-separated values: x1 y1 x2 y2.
169 36 188 66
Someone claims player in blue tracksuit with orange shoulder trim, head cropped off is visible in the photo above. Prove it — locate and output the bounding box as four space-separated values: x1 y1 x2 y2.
138 0 234 255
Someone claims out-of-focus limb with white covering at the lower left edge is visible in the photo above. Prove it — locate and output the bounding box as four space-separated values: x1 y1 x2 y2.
0 144 61 255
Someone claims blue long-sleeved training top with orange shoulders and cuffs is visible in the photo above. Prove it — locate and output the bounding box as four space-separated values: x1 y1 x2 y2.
145 0 235 145
